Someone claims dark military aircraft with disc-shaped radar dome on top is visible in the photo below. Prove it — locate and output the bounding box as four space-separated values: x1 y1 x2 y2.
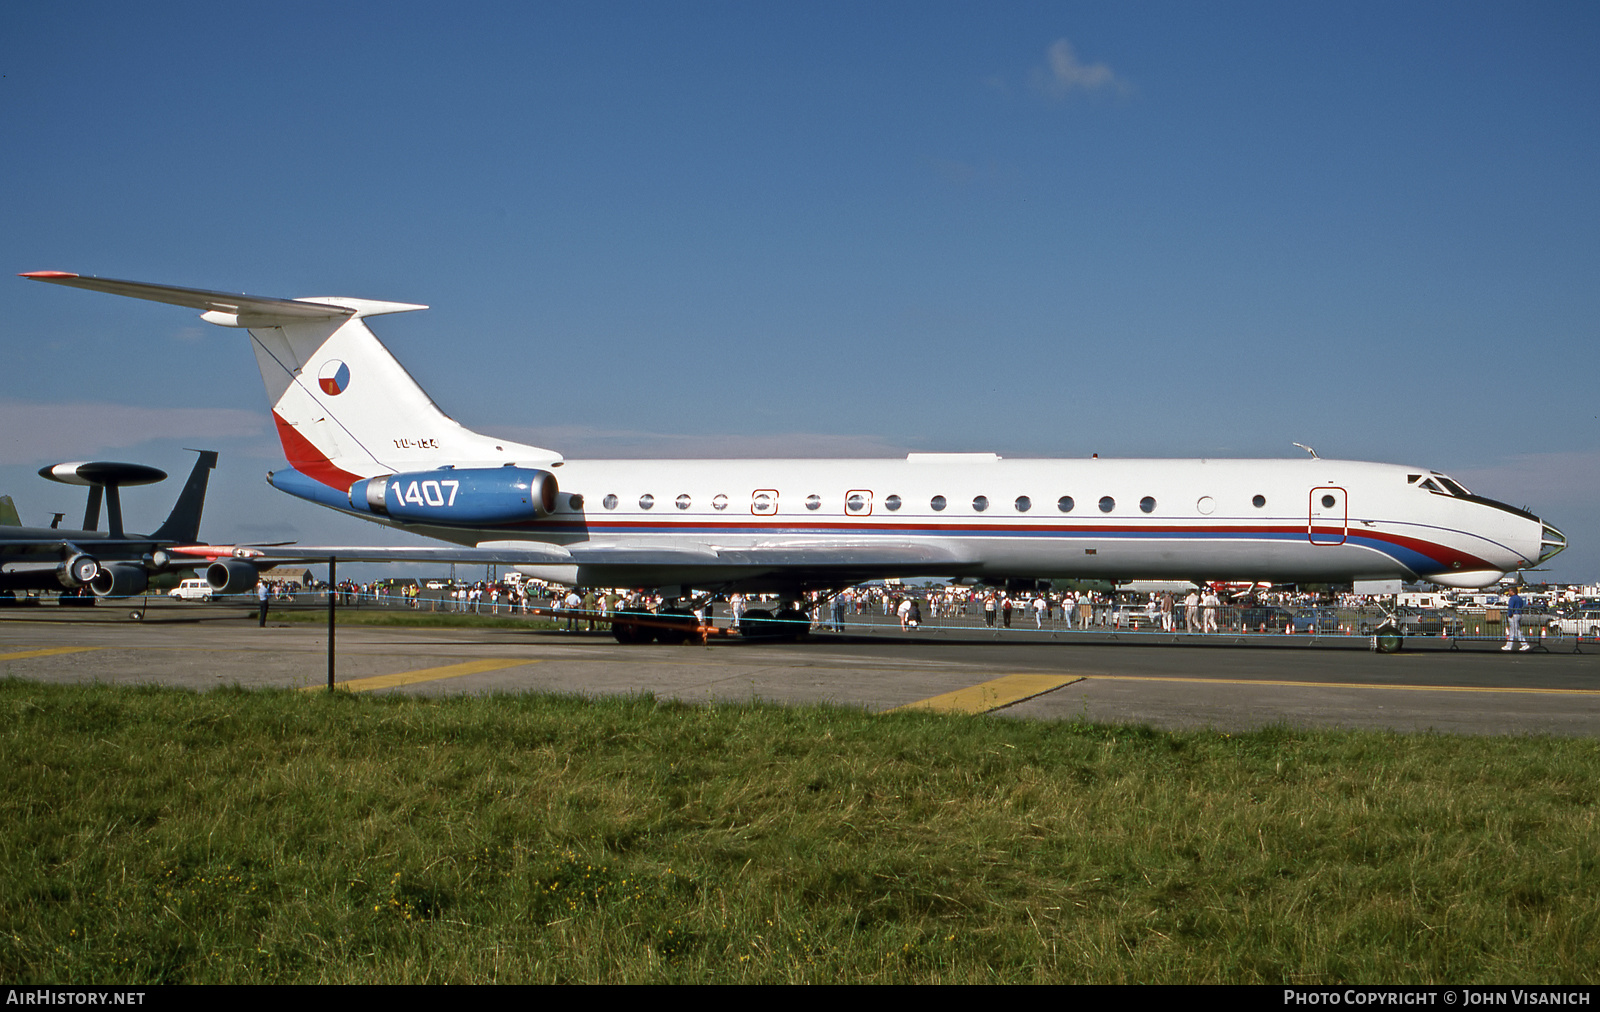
0 450 216 597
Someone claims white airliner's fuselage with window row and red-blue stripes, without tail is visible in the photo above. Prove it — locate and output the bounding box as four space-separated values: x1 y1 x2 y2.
377 455 1542 584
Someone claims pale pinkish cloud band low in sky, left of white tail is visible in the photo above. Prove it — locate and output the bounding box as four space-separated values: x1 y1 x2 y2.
0 400 269 464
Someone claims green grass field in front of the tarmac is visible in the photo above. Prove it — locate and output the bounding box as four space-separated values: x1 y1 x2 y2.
0 681 1600 983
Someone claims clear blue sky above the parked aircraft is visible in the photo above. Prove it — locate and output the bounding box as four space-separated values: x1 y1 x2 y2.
0 2 1600 580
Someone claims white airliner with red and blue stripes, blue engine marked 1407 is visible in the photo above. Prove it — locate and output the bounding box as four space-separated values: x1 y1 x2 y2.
22 271 1566 597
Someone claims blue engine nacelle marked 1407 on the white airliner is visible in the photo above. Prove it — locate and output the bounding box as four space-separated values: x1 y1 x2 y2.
350 468 557 527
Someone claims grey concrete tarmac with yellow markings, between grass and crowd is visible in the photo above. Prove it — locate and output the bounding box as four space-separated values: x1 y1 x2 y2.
0 605 1600 737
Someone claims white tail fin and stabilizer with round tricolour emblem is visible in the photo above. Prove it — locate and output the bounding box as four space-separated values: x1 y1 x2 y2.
22 271 562 492
